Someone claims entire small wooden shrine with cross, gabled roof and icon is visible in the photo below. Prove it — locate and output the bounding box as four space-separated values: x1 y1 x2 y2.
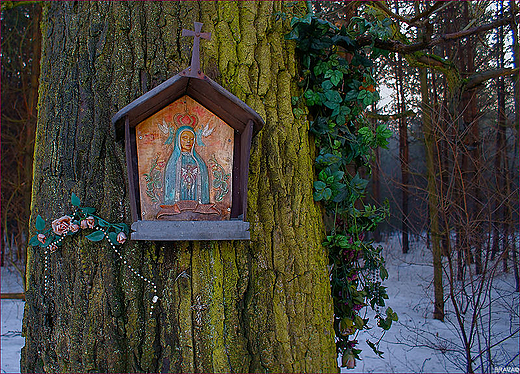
112 22 264 241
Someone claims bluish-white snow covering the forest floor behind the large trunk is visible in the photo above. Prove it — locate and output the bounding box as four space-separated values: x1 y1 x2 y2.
0 236 520 373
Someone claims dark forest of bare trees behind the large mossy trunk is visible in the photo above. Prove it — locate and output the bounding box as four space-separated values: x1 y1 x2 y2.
1 1 520 370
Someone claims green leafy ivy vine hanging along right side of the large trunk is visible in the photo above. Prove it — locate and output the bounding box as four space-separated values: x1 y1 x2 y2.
286 14 397 368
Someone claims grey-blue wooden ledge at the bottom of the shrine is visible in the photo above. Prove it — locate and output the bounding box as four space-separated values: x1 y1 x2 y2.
131 220 250 241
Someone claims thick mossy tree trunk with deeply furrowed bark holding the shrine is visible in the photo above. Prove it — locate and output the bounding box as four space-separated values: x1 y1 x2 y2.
21 1 337 372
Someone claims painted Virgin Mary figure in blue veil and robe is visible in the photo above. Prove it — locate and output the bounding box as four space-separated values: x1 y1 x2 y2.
164 126 209 205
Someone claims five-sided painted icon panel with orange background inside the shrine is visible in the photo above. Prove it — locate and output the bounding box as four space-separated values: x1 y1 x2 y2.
136 95 234 221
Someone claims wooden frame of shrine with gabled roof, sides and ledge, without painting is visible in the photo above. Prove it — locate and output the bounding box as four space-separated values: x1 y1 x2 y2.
112 68 264 240
